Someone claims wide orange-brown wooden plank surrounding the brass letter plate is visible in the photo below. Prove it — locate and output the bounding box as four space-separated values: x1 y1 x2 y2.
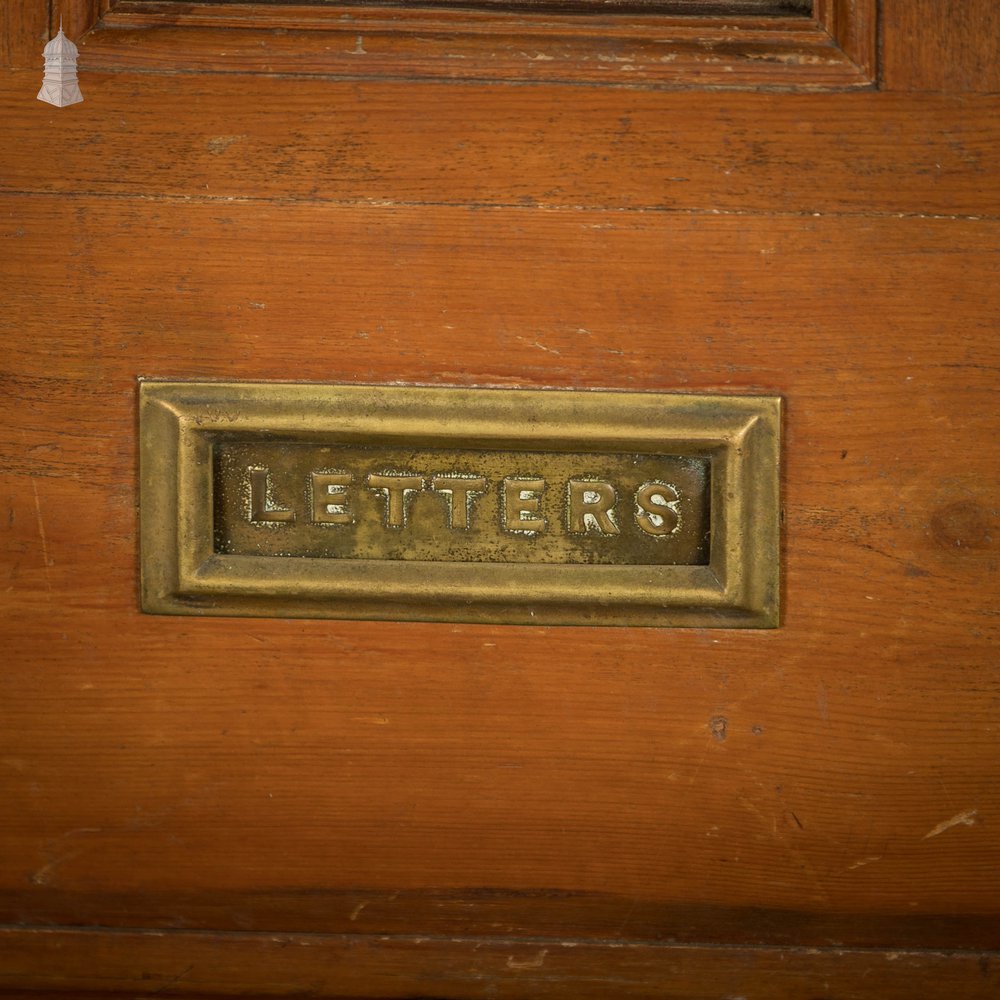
0 195 1000 946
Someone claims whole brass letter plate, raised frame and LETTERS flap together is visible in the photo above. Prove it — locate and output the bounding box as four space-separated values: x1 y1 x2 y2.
139 381 781 628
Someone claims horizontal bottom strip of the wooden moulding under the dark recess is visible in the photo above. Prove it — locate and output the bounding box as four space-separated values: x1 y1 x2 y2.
85 22 872 91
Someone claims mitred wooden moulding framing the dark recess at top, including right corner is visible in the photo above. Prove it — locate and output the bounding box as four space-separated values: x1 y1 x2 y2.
88 0 876 90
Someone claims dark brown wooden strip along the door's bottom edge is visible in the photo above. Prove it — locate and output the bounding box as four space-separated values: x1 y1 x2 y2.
0 930 1000 1000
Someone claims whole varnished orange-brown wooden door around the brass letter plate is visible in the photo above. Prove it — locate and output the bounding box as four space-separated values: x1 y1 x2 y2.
0 0 1000 1000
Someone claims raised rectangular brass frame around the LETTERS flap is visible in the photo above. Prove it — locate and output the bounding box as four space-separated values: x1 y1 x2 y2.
139 380 781 628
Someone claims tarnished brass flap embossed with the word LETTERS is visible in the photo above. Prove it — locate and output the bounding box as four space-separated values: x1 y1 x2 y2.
213 439 710 565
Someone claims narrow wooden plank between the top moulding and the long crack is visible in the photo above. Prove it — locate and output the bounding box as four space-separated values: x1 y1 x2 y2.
0 71 1000 216
